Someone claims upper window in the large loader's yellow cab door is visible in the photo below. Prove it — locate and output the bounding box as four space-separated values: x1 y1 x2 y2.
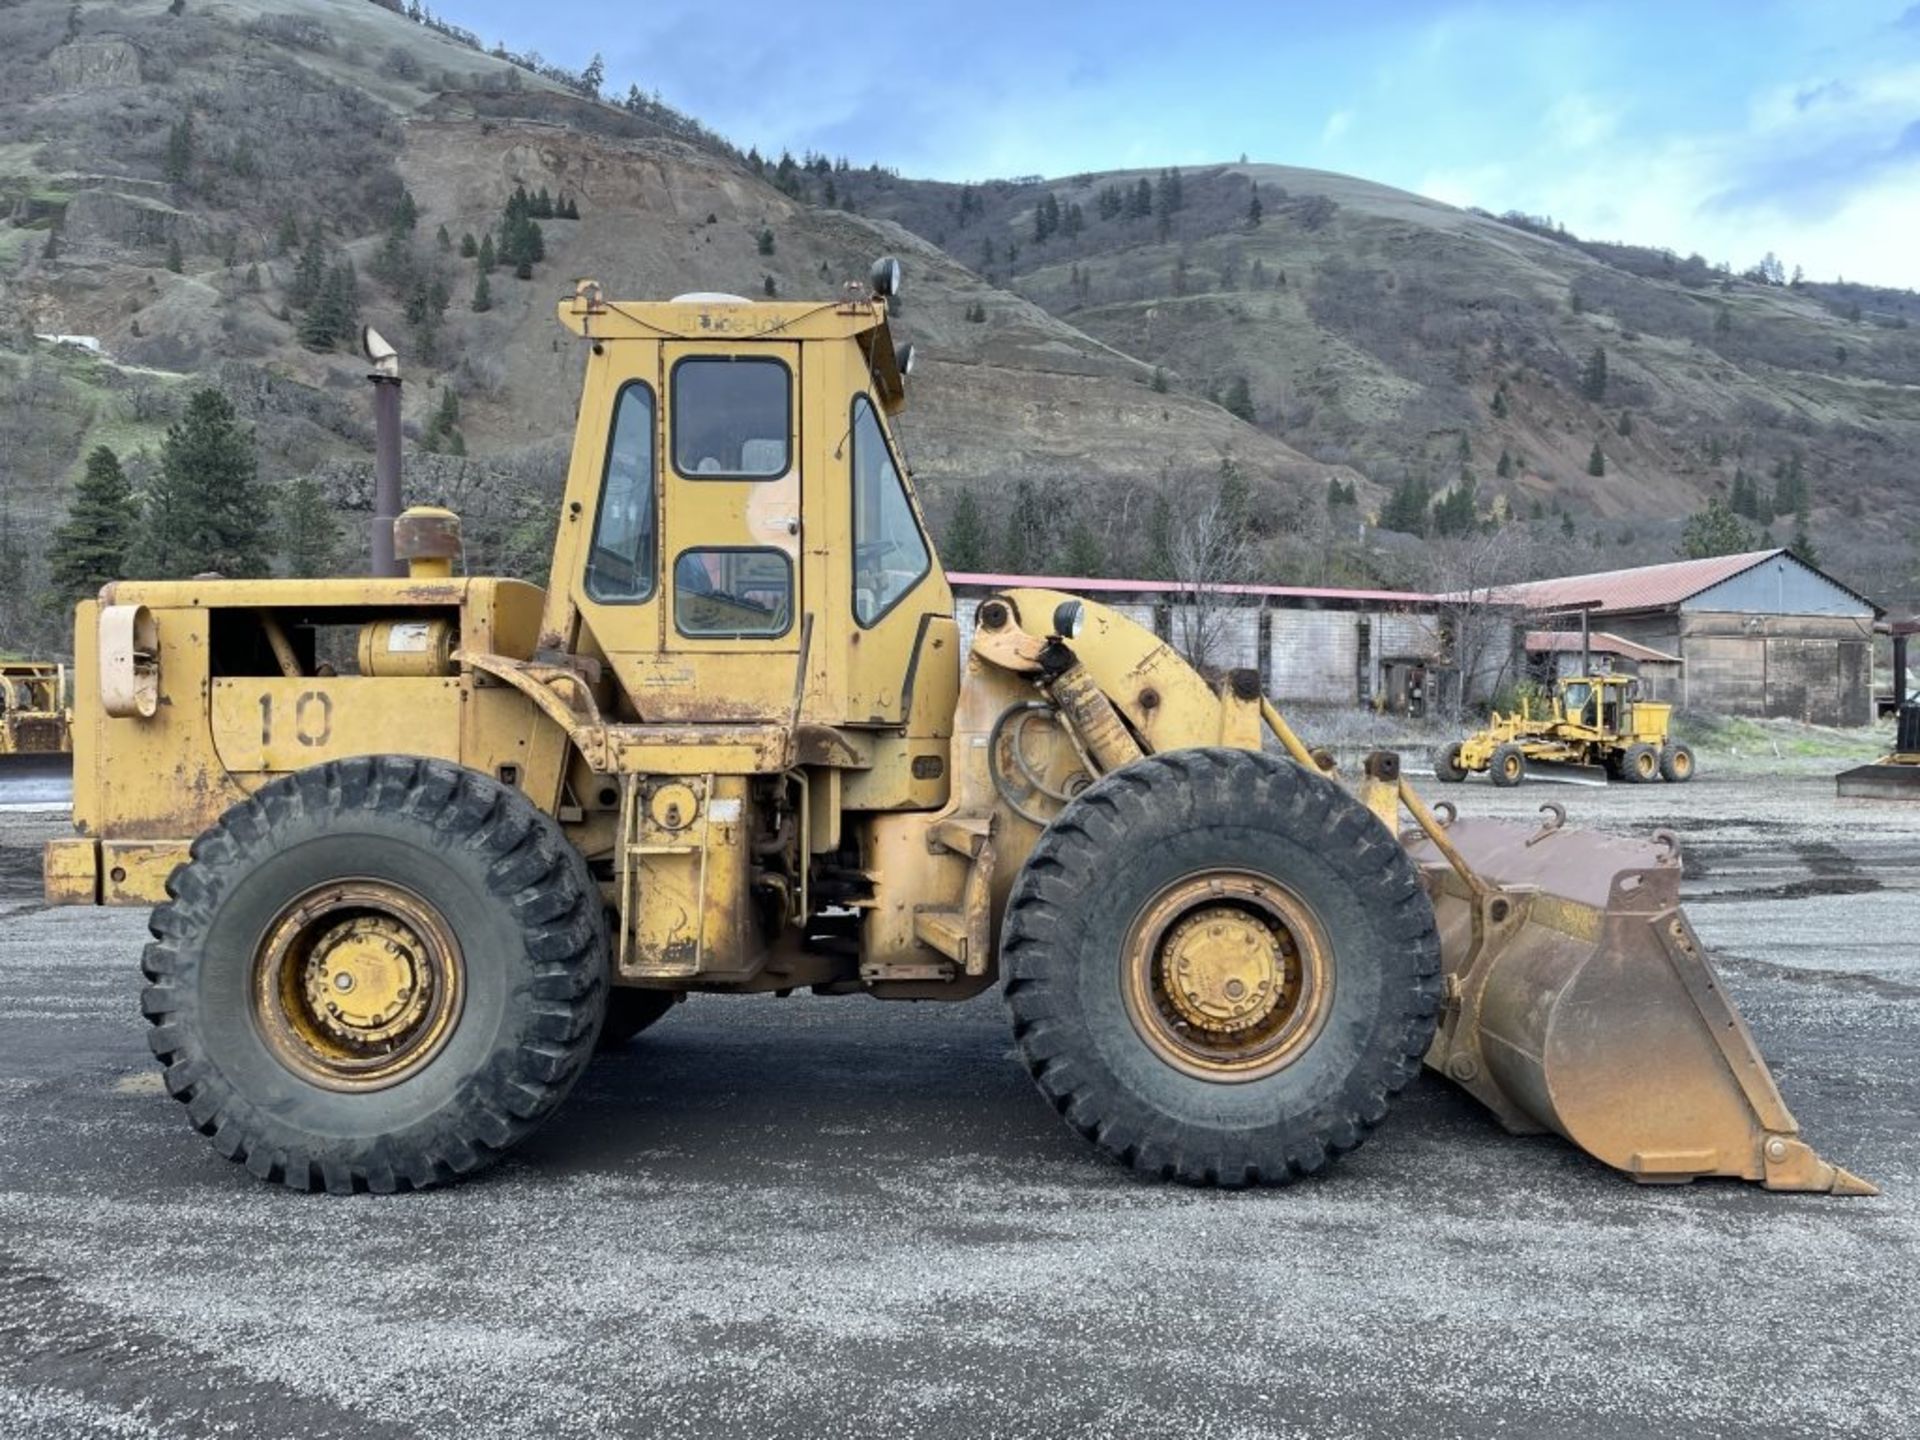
672 355 793 480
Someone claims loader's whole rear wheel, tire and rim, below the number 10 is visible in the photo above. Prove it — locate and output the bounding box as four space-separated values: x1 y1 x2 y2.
140 756 607 1194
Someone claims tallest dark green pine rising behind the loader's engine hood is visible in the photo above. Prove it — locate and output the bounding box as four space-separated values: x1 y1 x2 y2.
138 390 273 580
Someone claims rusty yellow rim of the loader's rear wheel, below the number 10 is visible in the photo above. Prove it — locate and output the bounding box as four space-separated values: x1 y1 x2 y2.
253 879 467 1091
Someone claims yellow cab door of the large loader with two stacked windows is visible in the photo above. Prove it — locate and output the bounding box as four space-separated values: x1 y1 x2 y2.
632 342 803 720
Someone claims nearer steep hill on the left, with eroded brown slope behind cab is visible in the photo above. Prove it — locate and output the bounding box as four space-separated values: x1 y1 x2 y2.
0 0 1357 639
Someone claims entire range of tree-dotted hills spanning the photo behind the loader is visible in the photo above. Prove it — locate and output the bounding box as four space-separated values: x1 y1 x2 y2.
0 0 1920 660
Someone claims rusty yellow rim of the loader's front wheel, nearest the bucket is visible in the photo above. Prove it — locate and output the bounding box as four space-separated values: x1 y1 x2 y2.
1121 870 1332 1081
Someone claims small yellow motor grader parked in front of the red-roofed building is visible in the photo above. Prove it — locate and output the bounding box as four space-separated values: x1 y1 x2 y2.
1432 674 1693 785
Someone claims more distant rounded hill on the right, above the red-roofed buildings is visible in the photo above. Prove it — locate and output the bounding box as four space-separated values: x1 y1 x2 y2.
837 163 1920 603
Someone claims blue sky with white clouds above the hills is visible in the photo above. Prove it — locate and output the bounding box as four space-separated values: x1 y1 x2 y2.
436 0 1920 286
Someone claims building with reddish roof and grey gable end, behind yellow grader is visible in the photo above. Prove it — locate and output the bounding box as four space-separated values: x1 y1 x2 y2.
1498 549 1882 726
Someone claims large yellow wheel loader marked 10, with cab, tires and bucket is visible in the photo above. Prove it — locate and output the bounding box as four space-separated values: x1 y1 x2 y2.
46 263 1870 1192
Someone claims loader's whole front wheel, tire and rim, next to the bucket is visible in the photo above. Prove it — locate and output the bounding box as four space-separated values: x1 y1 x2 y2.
1002 749 1440 1187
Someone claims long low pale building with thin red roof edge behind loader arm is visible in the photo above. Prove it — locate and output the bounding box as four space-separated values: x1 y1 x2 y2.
947 574 1521 714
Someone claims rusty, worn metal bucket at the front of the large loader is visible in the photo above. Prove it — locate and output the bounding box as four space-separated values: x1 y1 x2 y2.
1405 804 1878 1194
